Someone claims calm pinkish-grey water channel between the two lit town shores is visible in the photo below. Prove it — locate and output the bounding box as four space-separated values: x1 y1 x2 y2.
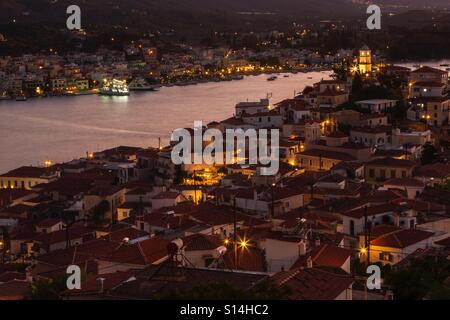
0 72 329 173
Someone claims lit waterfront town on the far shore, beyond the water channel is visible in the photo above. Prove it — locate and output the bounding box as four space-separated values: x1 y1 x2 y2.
0 31 352 101
